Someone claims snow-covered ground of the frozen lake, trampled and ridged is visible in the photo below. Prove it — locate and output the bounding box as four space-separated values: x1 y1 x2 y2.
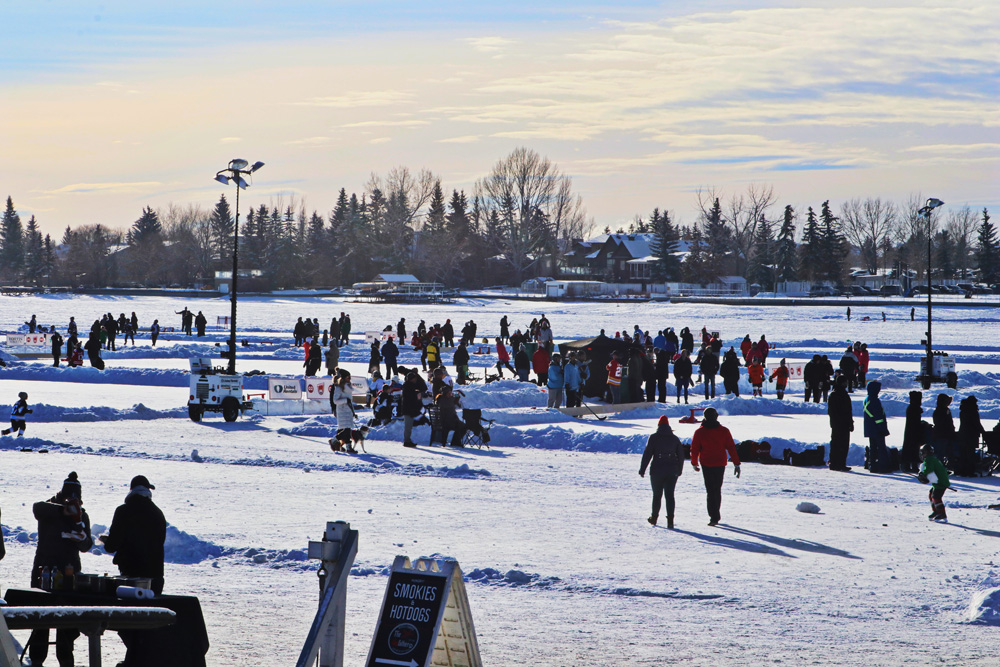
0 295 1000 666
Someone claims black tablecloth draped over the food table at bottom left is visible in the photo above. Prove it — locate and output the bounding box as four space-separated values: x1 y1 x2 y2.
4 588 209 667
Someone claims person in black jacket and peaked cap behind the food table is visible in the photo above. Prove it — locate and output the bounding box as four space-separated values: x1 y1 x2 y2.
101 475 167 595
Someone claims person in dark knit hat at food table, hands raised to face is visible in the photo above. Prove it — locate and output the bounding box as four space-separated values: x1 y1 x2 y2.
28 472 94 667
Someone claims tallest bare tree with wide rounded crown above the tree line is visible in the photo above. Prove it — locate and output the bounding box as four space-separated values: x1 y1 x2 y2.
474 148 588 282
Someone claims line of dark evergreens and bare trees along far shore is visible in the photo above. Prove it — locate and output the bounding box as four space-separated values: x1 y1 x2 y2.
0 148 1000 290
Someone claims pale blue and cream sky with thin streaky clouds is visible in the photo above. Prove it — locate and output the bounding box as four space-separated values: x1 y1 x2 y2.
0 0 1000 235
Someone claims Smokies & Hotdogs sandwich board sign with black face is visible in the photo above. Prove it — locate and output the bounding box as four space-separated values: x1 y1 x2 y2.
365 556 483 667
